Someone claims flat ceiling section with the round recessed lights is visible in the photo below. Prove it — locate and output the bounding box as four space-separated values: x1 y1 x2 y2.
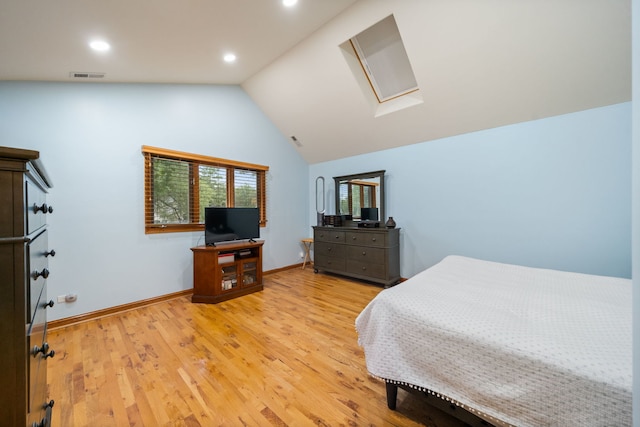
0 0 355 84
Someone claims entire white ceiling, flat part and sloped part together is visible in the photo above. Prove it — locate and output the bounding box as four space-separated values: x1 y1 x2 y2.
0 0 631 164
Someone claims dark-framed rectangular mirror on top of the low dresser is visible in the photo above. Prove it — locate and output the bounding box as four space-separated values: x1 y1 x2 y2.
333 170 385 222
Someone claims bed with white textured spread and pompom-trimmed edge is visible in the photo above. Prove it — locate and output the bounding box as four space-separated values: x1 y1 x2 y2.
356 256 632 427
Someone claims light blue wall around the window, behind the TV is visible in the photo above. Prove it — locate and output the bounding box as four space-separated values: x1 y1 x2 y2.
0 82 308 319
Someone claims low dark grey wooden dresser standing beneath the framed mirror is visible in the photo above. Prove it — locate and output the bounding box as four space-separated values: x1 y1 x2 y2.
313 226 400 286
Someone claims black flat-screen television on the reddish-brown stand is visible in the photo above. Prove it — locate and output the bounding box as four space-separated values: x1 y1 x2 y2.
204 207 260 246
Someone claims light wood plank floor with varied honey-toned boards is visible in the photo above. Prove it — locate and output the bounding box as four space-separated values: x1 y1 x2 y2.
48 268 465 427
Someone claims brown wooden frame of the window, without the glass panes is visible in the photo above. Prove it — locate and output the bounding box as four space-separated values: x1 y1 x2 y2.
142 145 269 234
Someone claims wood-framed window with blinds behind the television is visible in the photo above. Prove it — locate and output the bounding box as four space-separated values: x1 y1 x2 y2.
142 146 269 233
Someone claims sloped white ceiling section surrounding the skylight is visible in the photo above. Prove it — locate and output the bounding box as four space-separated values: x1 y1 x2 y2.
242 0 631 163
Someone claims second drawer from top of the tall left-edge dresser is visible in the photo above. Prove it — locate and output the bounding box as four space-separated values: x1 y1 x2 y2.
26 231 49 323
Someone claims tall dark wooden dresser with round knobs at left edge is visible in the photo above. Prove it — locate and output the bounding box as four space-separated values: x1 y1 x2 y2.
0 147 55 427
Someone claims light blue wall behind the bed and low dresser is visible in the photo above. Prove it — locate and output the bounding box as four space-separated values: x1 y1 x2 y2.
309 103 631 277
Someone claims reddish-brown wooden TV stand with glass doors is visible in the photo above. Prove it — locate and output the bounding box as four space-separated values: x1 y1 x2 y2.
191 241 264 303
